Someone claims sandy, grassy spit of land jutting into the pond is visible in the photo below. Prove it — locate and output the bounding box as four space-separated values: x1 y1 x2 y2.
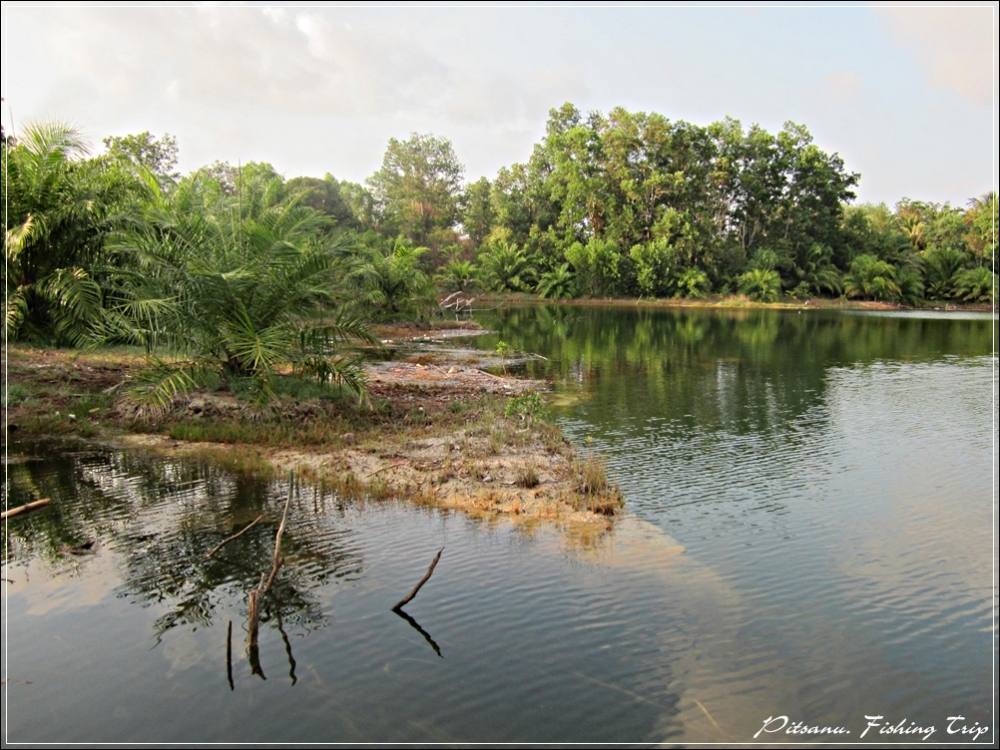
9 346 623 532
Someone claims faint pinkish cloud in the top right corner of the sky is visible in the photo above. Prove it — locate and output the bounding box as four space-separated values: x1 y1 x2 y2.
876 4 997 105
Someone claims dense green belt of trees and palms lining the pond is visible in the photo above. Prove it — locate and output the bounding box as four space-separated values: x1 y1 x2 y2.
3 104 997 401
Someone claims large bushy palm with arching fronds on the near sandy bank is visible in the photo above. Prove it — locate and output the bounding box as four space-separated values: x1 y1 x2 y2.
102 179 374 408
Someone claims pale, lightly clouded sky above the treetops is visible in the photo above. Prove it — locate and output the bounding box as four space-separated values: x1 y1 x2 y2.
0 2 998 205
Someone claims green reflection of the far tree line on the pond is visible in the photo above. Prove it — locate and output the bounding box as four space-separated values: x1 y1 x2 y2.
476 305 991 435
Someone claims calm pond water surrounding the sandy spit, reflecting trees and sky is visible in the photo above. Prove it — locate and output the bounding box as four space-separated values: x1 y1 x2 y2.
4 307 996 742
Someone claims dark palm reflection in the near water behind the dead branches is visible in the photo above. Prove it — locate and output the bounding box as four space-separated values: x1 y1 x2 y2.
4 443 363 648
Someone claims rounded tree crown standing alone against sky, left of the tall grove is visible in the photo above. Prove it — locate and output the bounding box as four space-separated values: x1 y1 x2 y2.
368 133 464 245
